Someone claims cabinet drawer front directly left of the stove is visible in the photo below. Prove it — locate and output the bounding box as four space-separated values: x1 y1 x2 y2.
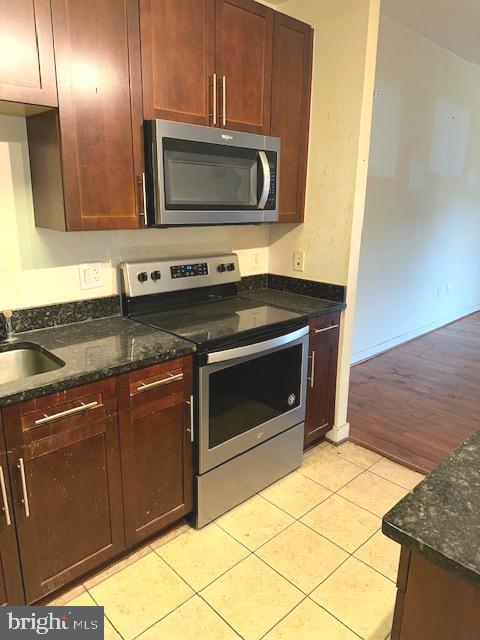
117 357 192 411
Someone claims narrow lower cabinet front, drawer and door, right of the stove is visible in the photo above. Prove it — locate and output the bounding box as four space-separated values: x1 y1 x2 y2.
304 314 339 448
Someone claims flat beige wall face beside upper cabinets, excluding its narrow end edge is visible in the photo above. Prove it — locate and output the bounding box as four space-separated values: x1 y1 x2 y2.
270 0 376 285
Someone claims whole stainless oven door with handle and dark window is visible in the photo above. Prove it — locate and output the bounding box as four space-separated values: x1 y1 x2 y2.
199 327 308 474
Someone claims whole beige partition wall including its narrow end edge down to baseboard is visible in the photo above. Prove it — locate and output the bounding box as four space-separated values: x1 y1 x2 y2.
269 0 380 442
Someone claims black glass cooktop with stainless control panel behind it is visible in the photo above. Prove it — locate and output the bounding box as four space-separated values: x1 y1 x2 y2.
121 254 307 350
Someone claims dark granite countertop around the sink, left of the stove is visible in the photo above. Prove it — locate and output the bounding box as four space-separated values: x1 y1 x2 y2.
0 316 195 407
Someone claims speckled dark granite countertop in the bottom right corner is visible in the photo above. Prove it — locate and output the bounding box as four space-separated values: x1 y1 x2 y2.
382 431 480 588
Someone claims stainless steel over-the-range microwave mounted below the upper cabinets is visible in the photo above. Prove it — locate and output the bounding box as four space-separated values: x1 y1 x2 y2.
144 120 280 226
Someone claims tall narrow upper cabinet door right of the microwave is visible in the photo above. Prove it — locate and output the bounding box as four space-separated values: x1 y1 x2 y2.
271 13 313 222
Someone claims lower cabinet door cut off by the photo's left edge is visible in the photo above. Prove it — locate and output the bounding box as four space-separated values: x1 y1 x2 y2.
0 450 25 606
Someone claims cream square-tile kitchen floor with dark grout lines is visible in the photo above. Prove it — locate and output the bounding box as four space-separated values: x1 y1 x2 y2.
49 442 422 640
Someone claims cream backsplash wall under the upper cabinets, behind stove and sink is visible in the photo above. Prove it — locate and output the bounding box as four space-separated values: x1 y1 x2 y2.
0 116 269 310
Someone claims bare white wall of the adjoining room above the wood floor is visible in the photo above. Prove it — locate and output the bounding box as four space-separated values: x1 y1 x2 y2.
353 16 480 362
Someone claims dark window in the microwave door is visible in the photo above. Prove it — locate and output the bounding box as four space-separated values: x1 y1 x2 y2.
163 138 263 211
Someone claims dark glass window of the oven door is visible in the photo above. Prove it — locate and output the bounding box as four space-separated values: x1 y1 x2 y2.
208 344 302 449
